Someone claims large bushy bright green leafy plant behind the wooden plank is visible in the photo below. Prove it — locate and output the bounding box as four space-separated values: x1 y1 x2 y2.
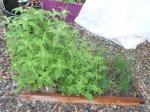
4 8 109 99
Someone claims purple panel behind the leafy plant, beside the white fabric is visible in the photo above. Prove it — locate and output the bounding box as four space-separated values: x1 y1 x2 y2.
42 0 82 23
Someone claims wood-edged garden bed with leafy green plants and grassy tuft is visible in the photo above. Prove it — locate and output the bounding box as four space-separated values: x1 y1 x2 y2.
2 8 143 105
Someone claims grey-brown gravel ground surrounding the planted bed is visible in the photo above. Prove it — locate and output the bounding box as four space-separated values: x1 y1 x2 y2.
0 10 150 112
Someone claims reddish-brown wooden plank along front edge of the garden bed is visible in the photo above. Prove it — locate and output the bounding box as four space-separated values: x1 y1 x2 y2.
20 92 145 106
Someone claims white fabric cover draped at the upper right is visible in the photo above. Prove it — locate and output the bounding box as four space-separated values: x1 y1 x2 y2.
75 0 150 49
